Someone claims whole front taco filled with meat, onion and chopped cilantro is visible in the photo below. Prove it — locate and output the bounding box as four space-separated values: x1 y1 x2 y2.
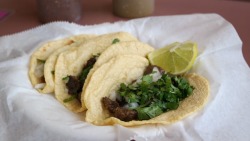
84 55 209 126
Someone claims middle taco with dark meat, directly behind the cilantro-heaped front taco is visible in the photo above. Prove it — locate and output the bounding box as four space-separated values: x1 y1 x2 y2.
55 32 153 112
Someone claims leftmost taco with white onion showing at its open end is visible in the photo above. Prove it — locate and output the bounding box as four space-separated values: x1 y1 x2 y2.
29 35 93 93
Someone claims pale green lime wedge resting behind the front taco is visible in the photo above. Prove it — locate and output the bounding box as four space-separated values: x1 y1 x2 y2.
148 42 198 74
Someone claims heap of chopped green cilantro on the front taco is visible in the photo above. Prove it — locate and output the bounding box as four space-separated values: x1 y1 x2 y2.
118 74 194 120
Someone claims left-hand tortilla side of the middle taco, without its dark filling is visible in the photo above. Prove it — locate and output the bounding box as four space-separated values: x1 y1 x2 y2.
55 32 141 113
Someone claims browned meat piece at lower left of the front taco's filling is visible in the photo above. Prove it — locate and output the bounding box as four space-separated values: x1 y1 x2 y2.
101 97 137 121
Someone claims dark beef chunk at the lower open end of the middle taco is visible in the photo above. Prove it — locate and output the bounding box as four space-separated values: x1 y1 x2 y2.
66 76 81 95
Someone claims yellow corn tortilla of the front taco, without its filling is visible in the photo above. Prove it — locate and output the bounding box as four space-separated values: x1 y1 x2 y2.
84 55 209 126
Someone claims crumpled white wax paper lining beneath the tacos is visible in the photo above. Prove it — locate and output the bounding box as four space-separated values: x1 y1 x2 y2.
0 14 250 141
